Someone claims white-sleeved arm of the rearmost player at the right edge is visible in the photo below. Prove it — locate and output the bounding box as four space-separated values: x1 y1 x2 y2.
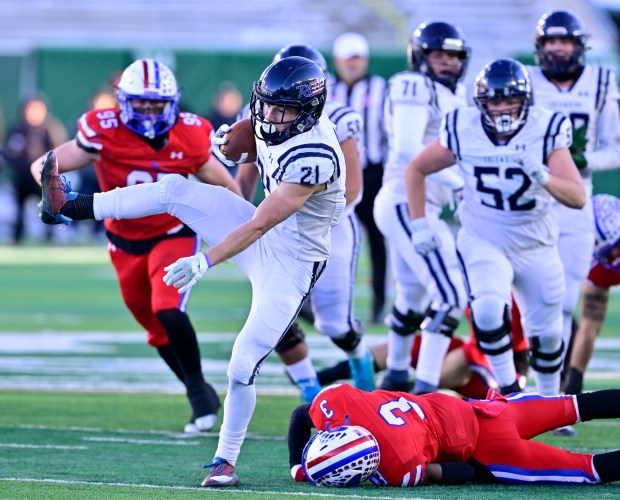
585 72 620 172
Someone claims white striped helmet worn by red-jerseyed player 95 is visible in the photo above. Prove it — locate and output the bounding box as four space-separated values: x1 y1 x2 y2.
116 59 181 139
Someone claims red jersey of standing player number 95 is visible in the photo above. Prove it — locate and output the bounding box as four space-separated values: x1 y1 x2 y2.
76 108 213 240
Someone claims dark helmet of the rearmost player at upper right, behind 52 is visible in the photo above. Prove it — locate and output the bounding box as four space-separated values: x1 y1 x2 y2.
534 10 590 82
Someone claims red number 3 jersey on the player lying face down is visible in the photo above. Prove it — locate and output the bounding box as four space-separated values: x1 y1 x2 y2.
310 384 479 486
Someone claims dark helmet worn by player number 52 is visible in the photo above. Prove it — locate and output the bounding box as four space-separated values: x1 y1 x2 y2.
474 59 532 136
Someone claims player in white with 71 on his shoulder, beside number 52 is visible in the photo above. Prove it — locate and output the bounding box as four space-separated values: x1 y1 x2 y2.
374 21 470 394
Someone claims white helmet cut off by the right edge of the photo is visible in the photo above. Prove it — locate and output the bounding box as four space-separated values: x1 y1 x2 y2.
592 194 620 271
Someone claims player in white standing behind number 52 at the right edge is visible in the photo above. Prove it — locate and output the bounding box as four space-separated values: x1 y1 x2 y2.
528 10 620 394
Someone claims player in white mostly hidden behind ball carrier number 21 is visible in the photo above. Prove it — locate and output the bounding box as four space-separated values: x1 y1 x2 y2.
229 43 375 403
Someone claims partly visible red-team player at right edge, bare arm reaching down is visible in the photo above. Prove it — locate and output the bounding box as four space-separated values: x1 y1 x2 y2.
564 194 620 394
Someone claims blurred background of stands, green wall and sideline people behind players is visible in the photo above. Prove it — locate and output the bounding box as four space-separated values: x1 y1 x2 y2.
0 0 620 244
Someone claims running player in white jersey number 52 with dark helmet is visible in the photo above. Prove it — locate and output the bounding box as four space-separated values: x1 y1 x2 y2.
407 59 586 395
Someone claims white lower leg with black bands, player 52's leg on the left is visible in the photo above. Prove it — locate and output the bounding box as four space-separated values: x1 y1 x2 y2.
471 295 521 394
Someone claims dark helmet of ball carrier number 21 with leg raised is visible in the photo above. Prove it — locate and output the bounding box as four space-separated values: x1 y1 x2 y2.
250 56 327 145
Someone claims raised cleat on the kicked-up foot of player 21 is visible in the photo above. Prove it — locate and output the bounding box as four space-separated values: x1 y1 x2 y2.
39 150 78 225
